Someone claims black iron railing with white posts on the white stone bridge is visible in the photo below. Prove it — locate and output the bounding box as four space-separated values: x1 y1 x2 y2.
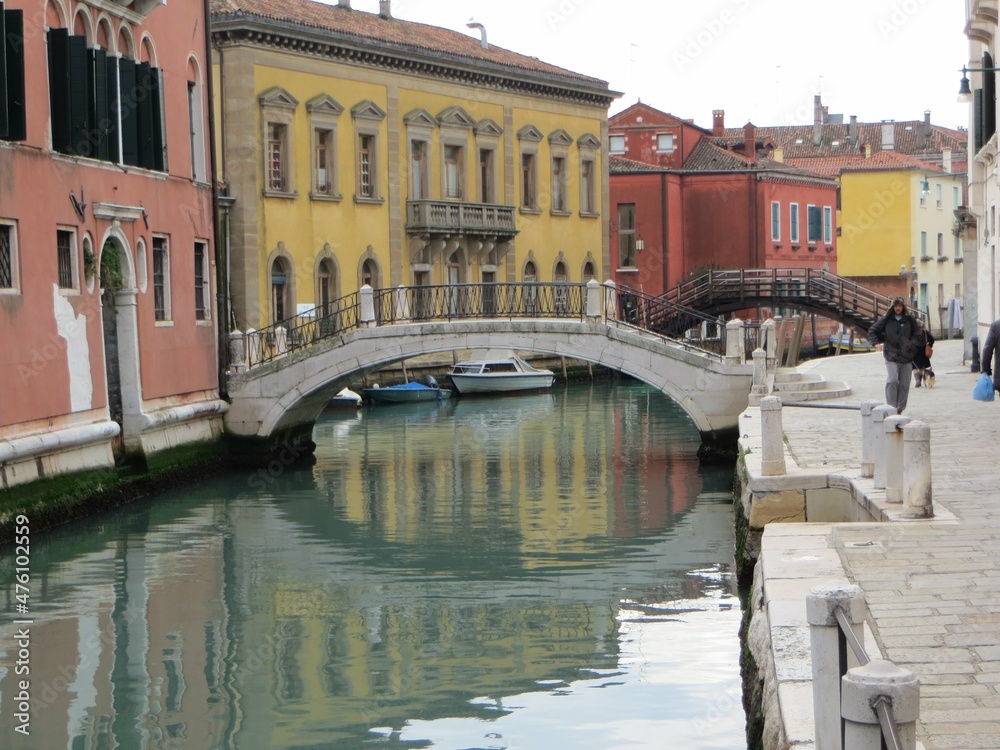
237 282 726 368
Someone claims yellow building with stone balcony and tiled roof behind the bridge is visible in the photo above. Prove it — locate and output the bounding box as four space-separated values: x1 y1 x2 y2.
212 0 615 330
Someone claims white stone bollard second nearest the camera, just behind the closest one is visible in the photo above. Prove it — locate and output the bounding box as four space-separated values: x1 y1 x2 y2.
806 583 865 750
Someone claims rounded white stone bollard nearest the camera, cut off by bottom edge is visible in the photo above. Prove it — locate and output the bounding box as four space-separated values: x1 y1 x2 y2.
840 659 920 750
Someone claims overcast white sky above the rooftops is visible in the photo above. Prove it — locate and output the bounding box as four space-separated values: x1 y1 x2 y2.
326 0 969 134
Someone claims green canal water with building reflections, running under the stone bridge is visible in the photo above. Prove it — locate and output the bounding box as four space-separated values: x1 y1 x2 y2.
0 380 746 750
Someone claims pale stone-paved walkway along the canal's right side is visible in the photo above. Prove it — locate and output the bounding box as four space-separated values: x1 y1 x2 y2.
782 341 1000 750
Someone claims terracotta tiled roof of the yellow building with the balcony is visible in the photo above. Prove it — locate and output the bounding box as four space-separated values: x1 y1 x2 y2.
211 0 614 88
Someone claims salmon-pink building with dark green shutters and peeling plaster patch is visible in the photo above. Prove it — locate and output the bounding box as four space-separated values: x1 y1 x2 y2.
0 0 225 487
